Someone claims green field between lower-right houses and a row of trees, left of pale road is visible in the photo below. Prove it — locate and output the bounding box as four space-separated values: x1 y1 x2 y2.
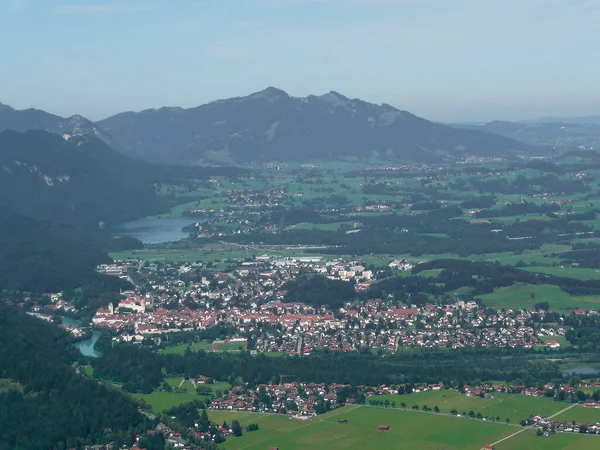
367 391 568 424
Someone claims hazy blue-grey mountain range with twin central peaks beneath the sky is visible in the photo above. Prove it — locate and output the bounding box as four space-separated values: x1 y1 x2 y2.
0 87 536 165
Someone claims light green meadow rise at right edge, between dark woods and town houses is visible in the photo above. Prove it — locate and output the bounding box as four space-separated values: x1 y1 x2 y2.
479 283 600 312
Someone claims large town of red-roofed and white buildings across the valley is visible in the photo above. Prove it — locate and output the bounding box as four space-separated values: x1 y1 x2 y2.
34 253 596 355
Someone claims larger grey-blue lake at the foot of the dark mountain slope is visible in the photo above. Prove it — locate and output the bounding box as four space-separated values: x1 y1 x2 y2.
112 217 198 244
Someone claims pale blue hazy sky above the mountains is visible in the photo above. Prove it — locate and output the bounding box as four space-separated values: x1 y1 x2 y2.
0 0 600 122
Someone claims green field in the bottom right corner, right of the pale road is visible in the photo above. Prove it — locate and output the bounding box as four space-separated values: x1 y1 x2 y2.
496 430 600 450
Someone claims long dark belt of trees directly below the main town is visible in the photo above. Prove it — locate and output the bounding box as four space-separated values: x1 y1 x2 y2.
95 345 562 387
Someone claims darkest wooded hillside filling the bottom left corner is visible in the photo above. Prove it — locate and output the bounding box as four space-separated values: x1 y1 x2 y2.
0 303 148 450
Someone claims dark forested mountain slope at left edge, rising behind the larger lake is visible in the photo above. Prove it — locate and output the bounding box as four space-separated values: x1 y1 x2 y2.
0 131 166 225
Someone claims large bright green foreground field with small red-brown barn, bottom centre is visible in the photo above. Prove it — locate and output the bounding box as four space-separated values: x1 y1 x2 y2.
214 406 518 450
